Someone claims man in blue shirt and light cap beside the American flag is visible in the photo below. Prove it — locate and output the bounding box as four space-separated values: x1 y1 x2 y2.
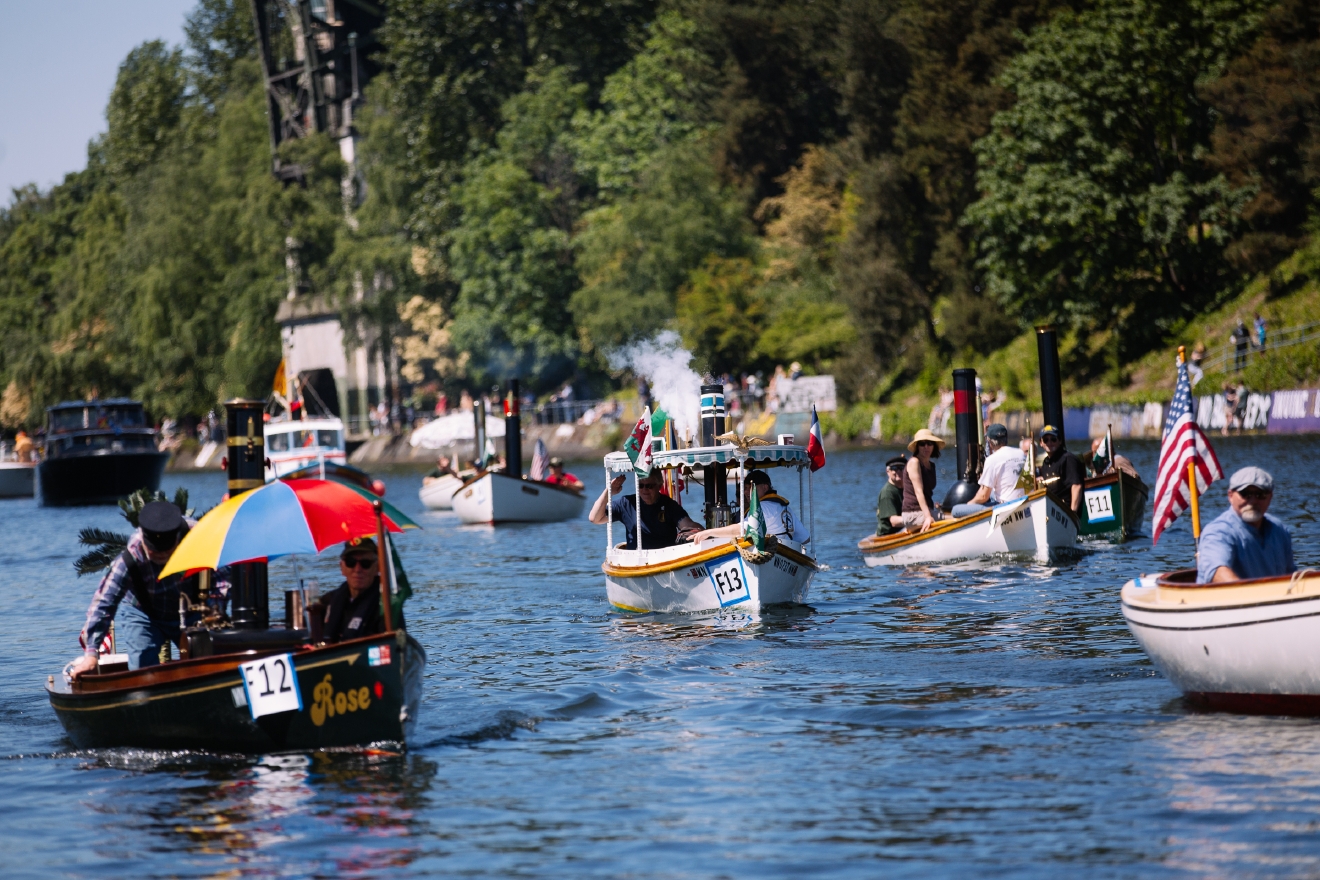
1196 467 1298 583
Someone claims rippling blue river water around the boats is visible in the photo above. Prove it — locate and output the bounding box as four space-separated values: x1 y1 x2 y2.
0 438 1320 877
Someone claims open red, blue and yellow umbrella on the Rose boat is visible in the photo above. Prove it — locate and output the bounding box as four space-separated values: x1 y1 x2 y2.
160 480 416 578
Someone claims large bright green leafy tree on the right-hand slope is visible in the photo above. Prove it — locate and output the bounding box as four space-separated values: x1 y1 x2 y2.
966 0 1261 369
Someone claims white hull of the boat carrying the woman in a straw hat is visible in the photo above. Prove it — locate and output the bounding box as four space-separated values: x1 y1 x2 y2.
859 492 1077 566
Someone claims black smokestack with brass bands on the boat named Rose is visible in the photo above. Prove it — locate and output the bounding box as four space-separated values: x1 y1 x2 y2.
224 400 271 629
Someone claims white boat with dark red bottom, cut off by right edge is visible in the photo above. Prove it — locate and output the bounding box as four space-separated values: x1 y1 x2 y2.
1122 570 1320 715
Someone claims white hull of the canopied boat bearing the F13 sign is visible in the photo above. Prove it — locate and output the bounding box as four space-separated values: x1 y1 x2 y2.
603 541 816 613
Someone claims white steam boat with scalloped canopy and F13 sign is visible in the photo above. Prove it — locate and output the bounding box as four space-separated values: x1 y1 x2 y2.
601 445 818 613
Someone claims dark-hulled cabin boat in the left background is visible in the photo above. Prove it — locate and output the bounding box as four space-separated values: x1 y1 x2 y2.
37 397 169 507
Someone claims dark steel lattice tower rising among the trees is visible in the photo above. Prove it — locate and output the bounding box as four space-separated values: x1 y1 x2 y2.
251 0 385 182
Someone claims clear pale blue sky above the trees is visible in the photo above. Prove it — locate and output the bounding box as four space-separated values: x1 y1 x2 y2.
0 0 195 204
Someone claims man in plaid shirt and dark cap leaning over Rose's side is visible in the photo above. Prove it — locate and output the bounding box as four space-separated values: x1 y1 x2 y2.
73 501 197 678
